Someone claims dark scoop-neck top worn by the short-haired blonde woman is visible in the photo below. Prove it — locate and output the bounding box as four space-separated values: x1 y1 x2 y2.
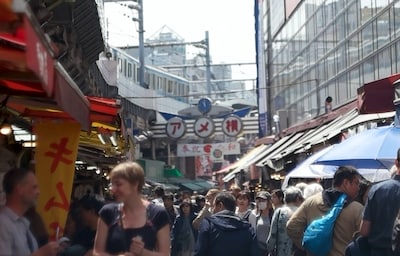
99 203 169 254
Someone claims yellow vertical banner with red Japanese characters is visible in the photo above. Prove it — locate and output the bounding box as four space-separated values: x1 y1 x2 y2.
33 121 81 240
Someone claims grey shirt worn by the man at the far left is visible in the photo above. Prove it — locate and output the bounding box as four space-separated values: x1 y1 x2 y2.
0 207 38 256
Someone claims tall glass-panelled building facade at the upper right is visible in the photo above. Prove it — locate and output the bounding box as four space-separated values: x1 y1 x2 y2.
262 0 400 129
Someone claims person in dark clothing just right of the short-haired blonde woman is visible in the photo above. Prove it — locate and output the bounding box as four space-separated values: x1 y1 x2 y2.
171 199 197 256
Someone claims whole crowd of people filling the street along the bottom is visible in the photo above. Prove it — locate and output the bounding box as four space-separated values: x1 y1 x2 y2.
0 150 400 256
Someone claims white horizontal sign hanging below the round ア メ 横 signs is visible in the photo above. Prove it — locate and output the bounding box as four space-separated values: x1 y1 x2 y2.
177 142 240 158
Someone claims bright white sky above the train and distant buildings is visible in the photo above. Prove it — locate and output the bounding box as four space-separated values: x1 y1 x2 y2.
105 0 255 78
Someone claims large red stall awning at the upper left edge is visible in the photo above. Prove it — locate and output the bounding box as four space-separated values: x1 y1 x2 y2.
0 7 91 130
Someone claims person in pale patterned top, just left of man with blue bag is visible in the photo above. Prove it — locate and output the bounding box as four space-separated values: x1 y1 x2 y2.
266 186 304 256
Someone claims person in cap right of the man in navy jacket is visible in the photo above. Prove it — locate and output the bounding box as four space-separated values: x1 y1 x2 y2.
256 191 272 255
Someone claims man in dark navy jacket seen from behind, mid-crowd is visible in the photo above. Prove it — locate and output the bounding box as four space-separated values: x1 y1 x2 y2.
194 192 260 256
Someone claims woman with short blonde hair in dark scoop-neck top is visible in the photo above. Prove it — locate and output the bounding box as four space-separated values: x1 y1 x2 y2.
93 161 170 256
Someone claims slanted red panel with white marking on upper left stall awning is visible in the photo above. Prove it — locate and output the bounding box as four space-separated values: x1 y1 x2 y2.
24 18 54 97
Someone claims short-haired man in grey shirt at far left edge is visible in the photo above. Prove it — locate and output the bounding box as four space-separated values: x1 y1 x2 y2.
0 168 59 256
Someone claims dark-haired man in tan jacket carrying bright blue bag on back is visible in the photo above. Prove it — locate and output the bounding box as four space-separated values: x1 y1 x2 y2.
286 166 363 256
